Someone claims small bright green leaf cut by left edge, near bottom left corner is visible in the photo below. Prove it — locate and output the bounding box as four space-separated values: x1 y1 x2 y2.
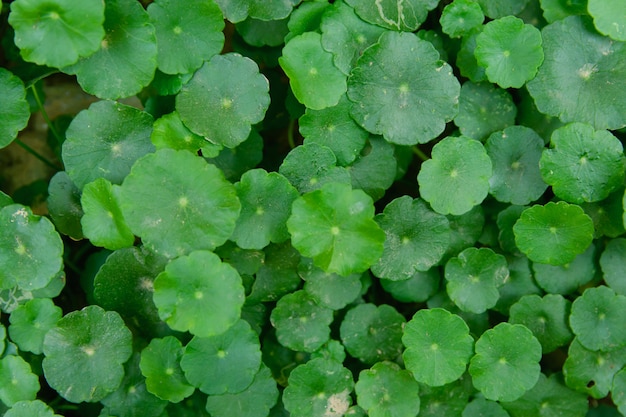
0 355 40 407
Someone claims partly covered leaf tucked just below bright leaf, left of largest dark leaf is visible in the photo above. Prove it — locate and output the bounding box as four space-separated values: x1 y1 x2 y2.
296 94 369 166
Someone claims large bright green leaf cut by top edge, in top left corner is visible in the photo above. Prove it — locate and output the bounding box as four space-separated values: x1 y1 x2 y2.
9 0 108 68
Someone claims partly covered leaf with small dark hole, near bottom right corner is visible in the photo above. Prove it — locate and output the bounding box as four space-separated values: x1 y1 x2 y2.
563 338 626 398
